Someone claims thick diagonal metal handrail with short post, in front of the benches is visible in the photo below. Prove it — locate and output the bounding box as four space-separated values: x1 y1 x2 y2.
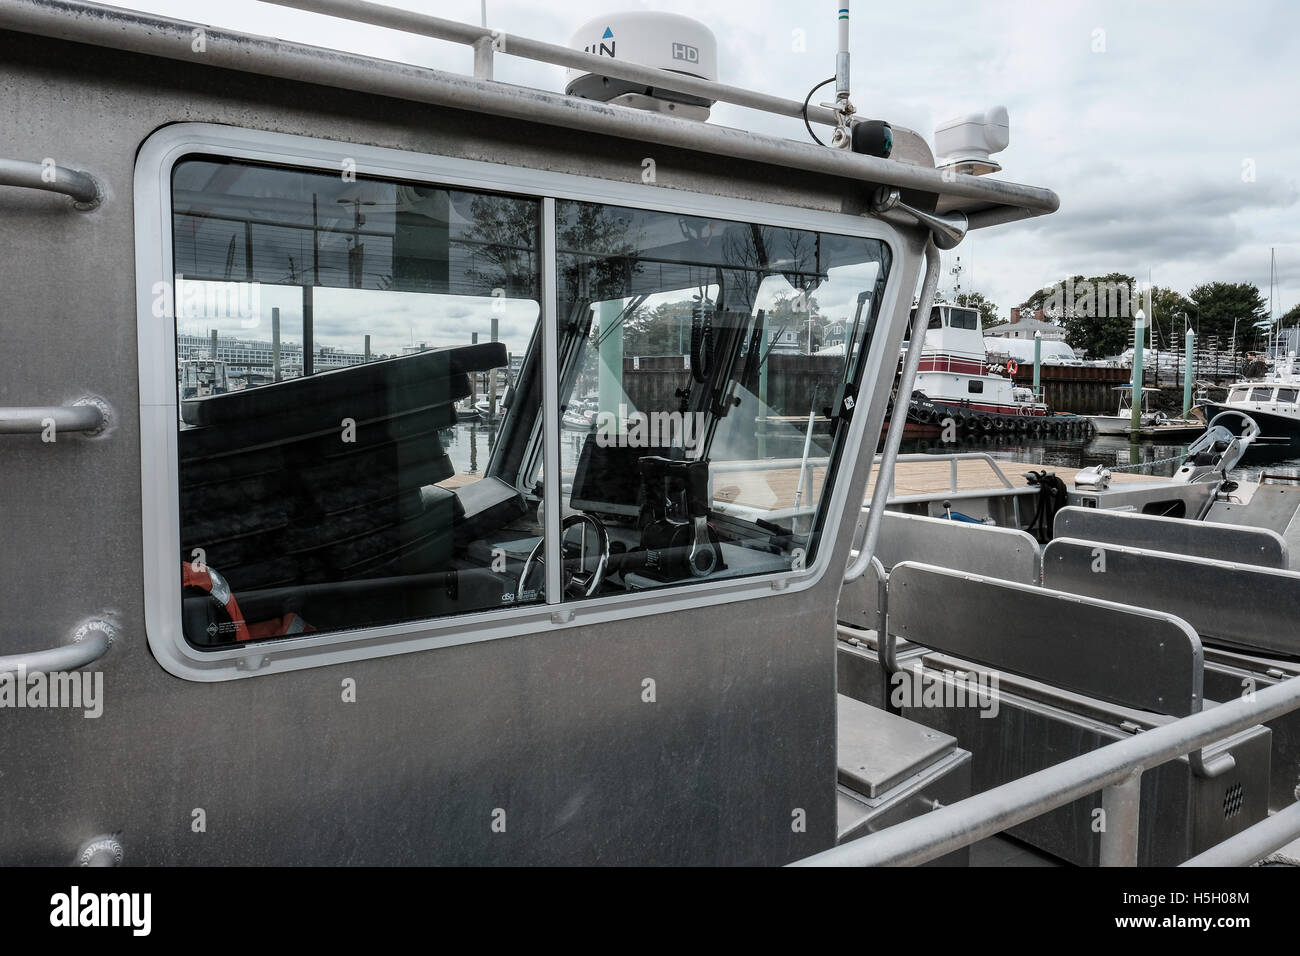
792 678 1300 866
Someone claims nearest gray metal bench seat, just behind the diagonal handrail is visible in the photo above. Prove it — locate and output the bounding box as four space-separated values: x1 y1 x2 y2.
881 562 1271 865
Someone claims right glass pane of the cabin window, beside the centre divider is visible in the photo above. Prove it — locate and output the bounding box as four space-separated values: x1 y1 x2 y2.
548 202 889 600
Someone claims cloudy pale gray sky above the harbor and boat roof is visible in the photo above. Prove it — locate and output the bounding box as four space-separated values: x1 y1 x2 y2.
116 0 1300 343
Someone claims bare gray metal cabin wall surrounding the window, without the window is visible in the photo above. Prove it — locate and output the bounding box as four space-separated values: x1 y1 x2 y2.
0 31 919 864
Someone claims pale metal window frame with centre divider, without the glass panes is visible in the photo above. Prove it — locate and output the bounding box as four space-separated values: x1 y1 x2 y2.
134 124 907 682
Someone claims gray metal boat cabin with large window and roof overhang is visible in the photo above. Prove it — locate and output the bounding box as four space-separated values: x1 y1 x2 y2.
0 0 1057 865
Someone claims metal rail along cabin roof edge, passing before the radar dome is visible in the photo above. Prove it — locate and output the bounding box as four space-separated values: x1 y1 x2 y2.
263 0 839 126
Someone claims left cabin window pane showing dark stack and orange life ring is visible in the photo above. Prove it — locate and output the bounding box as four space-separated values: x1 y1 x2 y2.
172 159 542 649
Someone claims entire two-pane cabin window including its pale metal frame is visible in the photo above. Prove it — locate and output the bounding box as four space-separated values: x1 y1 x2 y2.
135 130 897 680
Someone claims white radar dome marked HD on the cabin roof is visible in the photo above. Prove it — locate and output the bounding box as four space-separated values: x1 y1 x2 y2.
564 13 718 120
